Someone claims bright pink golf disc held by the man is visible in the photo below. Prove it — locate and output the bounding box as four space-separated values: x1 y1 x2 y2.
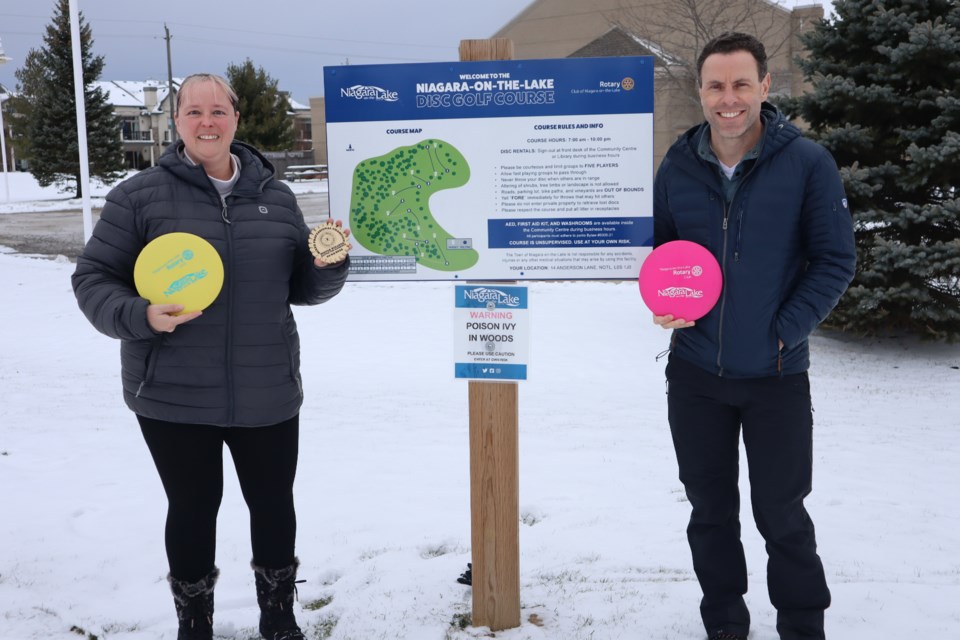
639 240 723 320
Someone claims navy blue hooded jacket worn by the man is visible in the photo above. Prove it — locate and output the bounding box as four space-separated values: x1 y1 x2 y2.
653 103 856 378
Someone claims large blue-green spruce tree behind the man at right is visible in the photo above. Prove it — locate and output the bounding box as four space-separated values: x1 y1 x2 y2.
782 0 960 340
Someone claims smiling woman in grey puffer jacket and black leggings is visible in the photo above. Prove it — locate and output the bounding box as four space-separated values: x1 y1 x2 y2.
73 74 349 640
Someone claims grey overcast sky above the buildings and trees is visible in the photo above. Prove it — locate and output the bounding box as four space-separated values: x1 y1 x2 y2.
0 0 832 104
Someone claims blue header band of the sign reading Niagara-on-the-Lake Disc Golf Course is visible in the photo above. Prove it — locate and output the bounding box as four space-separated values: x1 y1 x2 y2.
323 57 653 122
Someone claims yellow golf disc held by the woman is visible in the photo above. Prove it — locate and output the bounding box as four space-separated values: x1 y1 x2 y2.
133 233 223 313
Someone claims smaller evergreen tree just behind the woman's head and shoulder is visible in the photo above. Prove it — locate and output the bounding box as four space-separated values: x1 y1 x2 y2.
227 58 293 151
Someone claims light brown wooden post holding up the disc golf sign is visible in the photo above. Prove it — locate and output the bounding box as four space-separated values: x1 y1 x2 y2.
460 38 520 631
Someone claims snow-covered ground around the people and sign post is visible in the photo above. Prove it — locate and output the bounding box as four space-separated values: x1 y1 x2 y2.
0 174 960 640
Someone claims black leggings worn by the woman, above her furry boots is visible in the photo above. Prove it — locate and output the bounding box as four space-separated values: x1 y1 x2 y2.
137 416 300 582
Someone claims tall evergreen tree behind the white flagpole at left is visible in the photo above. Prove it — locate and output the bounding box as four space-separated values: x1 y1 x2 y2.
11 0 123 198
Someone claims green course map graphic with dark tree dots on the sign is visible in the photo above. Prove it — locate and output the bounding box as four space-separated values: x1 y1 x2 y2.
350 140 479 271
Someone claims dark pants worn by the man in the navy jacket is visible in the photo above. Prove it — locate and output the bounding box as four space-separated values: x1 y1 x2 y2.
666 357 830 640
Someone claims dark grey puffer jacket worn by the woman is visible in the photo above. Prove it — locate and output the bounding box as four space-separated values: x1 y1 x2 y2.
73 142 349 427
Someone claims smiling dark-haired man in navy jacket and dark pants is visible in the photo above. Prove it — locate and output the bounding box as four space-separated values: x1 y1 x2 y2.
654 33 856 640
